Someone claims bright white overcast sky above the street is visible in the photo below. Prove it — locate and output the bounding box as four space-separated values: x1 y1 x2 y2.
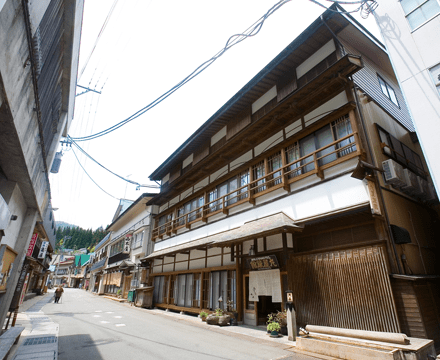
50 0 380 229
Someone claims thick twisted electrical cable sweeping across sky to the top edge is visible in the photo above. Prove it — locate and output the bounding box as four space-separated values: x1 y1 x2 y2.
71 0 292 141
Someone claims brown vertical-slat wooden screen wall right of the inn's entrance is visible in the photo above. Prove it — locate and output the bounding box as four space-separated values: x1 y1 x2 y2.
288 246 400 332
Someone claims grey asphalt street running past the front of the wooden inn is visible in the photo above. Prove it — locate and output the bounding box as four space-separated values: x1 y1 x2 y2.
42 289 315 360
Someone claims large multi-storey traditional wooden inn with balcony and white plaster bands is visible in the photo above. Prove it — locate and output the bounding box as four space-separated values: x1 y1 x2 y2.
145 6 440 346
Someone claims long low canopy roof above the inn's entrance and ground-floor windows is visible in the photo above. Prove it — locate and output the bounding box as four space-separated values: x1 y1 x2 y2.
142 212 304 260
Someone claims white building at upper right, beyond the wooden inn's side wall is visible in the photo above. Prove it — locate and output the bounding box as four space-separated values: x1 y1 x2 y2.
374 0 440 194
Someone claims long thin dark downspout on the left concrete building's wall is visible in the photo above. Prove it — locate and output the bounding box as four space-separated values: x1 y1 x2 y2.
22 0 52 203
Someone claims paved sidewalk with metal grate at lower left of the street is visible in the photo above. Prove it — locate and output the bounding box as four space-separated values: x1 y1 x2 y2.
7 291 59 360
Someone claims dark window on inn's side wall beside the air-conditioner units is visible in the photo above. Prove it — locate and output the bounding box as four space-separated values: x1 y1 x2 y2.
376 124 426 177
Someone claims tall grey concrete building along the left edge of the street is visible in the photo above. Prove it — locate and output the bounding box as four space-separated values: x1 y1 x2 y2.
0 0 84 330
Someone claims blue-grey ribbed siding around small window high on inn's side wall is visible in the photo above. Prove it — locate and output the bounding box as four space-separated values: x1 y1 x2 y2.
342 41 415 131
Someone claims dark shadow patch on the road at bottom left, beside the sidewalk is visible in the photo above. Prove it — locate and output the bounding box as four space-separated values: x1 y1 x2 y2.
58 334 105 360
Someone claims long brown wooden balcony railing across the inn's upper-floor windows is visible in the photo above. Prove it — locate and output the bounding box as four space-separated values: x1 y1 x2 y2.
152 132 361 240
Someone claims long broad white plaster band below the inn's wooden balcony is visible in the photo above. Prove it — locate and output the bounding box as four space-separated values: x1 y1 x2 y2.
154 174 369 252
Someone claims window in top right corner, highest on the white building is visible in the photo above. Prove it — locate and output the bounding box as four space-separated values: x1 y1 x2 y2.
400 0 440 30
